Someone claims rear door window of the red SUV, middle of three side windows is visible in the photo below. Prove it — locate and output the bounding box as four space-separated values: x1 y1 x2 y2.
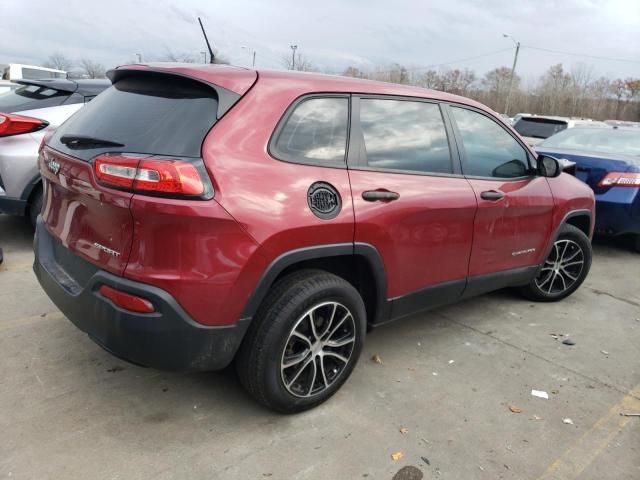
360 99 452 173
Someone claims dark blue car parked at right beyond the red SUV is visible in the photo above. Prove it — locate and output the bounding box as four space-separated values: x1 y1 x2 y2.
536 127 640 252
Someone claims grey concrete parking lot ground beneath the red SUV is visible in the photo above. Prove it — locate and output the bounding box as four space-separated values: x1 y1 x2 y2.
0 216 640 480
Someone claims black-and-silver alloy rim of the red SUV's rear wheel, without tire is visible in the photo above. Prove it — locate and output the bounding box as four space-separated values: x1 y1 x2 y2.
280 302 356 397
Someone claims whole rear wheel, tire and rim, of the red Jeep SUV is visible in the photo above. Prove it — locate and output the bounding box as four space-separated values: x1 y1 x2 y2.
236 270 366 413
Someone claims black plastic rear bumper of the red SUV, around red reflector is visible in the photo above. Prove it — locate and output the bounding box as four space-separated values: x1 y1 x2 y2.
33 218 250 371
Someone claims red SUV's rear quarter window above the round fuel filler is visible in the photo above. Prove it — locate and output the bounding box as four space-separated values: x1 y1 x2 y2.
273 98 349 165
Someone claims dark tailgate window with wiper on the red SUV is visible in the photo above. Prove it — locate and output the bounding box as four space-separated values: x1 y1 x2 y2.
49 74 218 160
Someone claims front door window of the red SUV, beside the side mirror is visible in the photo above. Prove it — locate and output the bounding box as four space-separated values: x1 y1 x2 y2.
452 107 529 178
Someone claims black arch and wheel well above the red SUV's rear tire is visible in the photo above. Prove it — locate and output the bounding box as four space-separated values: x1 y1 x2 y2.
242 243 390 324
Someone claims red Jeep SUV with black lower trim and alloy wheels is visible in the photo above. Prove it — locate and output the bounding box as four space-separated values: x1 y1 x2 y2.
34 64 594 412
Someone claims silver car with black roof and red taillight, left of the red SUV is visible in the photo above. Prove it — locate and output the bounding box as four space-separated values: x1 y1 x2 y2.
0 80 111 225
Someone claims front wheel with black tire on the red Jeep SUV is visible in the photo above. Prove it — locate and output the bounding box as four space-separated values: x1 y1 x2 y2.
521 224 592 302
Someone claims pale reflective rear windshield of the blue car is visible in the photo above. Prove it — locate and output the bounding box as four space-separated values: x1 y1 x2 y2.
539 127 640 157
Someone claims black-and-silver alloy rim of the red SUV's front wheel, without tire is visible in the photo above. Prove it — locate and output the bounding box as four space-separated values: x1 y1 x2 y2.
535 239 584 295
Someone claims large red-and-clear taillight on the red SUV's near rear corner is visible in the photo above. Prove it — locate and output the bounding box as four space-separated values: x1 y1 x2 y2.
94 154 213 200
